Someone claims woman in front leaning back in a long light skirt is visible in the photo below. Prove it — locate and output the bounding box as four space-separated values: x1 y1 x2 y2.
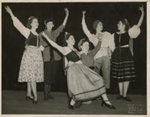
42 32 115 109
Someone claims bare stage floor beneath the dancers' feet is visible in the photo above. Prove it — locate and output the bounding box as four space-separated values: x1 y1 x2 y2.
1 90 147 115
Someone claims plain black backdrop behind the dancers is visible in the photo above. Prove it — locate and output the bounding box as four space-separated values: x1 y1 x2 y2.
2 2 147 94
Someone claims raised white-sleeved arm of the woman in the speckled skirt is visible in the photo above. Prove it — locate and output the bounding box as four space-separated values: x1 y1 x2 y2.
5 6 30 39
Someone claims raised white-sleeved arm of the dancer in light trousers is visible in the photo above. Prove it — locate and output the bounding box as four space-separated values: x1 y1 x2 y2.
81 11 93 43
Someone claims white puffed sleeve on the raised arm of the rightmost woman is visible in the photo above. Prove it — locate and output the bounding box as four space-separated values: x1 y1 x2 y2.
128 25 141 39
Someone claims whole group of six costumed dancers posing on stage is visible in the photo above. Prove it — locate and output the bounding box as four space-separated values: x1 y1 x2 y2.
5 6 144 109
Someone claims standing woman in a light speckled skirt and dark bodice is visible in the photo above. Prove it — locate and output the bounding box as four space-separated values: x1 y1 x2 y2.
5 6 44 104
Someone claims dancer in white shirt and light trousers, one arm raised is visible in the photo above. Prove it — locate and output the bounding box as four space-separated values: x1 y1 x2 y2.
81 11 115 89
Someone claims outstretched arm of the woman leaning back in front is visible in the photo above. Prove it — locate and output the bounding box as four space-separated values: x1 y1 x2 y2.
42 32 66 55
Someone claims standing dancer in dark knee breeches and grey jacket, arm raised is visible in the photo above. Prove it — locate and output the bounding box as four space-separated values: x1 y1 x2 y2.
39 8 69 100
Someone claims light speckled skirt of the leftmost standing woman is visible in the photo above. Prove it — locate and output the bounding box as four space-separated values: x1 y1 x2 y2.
18 46 44 82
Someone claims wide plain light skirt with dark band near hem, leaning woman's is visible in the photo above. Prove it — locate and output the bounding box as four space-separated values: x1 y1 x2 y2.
67 64 106 101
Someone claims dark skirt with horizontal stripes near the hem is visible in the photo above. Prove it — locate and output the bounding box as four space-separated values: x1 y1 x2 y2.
111 47 136 82
